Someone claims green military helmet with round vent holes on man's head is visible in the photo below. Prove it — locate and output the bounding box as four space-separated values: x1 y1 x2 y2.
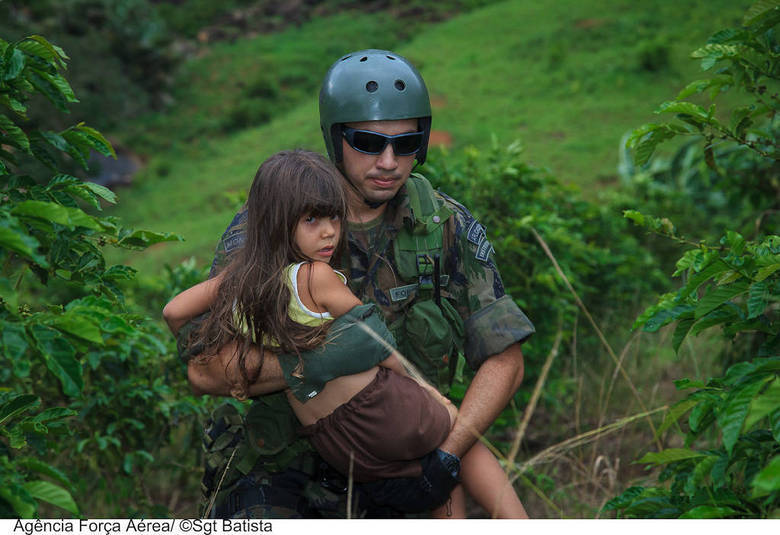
320 49 431 168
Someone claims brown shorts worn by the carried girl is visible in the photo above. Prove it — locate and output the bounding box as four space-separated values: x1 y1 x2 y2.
300 367 450 482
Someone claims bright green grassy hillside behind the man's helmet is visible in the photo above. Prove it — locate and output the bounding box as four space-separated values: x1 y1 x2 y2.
106 0 748 273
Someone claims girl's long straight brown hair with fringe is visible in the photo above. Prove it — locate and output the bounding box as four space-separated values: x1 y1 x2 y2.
194 149 346 398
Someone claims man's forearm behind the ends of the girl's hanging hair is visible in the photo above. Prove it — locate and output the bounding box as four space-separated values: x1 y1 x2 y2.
187 343 287 397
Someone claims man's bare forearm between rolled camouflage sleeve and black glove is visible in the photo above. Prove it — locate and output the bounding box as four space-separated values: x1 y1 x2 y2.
440 343 524 457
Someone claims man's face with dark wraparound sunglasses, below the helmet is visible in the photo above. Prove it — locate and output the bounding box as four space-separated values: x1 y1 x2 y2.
341 119 417 206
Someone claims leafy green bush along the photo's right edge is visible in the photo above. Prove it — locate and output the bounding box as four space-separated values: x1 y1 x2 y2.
605 2 780 518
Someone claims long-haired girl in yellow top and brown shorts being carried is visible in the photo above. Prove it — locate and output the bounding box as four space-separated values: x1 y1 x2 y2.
163 150 526 518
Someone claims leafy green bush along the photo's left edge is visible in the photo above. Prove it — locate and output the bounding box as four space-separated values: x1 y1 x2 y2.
0 32 204 518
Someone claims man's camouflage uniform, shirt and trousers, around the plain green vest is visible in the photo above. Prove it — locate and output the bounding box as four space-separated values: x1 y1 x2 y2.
184 177 534 518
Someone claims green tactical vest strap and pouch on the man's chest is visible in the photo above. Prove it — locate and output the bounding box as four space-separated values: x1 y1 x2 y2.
389 173 464 394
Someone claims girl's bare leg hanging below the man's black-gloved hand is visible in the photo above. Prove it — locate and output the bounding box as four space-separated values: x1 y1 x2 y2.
460 441 528 518
